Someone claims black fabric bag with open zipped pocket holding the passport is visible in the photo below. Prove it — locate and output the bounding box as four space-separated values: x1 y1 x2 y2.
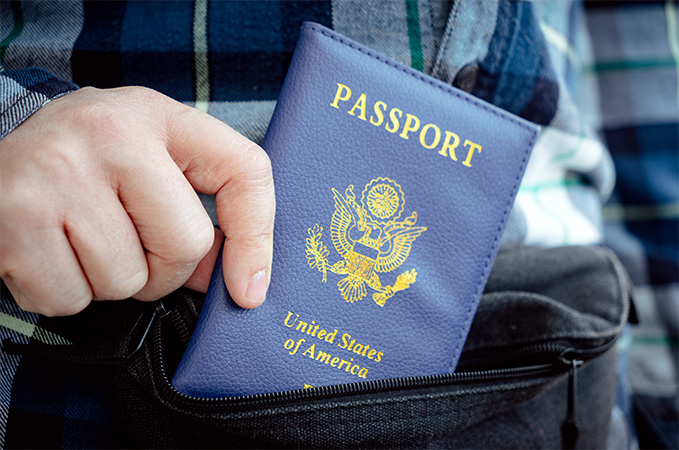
3 247 630 448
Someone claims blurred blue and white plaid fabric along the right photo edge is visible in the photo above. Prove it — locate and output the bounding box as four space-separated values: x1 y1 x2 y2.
584 1 679 448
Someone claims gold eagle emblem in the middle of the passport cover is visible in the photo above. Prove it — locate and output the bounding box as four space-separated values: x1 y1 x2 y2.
306 177 427 306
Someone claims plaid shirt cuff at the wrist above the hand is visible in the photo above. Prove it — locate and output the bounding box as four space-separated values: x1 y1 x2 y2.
0 67 78 139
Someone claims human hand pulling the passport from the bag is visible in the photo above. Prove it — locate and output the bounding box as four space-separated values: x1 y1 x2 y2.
0 87 275 316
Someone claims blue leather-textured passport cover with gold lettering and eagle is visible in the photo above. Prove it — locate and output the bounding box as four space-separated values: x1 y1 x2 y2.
173 23 537 397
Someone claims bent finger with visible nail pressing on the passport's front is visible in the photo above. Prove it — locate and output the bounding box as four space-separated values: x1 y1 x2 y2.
161 99 276 308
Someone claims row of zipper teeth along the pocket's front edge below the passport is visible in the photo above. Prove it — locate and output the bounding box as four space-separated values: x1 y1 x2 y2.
154 323 555 407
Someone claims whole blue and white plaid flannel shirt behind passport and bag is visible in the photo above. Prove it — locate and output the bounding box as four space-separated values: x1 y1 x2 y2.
0 0 679 447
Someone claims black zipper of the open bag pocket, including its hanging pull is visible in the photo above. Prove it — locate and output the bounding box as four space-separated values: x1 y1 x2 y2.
147 246 631 442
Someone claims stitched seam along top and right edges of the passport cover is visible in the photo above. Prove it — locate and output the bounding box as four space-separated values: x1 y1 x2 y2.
306 25 537 370
